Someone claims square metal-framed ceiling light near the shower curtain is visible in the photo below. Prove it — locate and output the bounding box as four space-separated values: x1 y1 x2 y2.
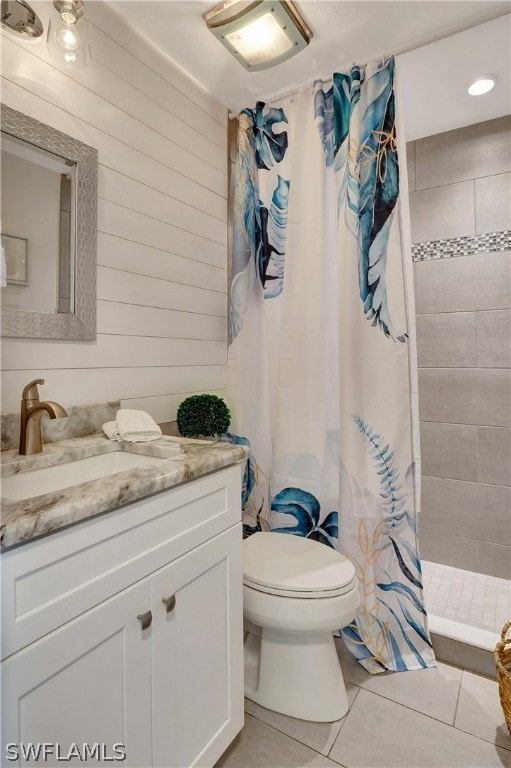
202 0 312 72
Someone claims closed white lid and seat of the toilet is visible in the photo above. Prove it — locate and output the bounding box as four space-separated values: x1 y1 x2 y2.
243 532 355 597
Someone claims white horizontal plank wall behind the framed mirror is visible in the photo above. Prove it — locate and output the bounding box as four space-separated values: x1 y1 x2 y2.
1 0 227 421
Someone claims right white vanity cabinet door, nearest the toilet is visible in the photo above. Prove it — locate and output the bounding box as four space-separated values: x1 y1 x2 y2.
151 525 243 768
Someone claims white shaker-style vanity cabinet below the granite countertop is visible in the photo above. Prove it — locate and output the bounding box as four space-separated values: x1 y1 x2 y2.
0 465 243 768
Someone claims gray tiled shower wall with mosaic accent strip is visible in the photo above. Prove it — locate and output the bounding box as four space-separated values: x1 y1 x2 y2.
407 117 511 578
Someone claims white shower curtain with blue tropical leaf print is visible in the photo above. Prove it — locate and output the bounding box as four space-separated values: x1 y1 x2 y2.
228 58 434 673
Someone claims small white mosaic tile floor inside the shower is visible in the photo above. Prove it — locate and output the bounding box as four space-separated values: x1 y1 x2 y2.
422 560 511 634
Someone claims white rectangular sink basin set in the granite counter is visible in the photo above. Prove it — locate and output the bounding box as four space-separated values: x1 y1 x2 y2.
1 445 181 501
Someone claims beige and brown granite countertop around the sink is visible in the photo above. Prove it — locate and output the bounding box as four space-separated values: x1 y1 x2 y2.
0 435 249 549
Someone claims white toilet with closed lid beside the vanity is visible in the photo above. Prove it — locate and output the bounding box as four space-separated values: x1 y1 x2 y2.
243 532 360 722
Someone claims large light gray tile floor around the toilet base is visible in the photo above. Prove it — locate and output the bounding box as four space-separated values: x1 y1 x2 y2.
216 641 511 768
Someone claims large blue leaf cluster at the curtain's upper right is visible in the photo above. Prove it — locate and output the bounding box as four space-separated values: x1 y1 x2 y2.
314 57 408 342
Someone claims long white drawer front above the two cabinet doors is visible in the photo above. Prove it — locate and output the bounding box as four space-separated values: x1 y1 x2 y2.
0 465 241 658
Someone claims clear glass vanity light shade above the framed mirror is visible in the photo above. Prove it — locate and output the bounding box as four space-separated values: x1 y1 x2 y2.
48 0 91 68
